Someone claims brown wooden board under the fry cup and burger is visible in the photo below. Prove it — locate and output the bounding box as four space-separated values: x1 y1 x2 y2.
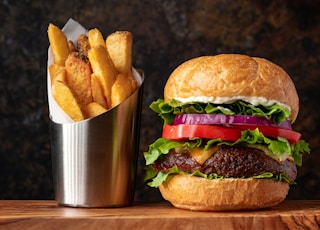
0 200 320 230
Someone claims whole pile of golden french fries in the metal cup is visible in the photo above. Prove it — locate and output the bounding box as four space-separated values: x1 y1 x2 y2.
48 23 138 121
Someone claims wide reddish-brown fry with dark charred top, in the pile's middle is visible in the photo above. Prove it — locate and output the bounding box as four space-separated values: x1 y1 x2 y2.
65 52 93 107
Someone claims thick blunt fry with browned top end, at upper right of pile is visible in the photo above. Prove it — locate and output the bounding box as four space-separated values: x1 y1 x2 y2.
106 31 133 75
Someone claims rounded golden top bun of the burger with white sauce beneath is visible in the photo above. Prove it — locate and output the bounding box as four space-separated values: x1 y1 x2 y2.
164 54 299 122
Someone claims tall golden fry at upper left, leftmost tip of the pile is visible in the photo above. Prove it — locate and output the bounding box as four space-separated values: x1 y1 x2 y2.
48 23 69 66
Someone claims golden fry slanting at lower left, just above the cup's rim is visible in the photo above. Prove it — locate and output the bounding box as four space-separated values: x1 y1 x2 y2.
52 81 85 121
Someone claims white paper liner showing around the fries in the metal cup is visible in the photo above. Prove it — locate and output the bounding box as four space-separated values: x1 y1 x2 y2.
47 18 142 124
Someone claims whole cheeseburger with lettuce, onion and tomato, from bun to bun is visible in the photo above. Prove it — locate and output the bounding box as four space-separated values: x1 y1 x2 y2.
144 54 310 211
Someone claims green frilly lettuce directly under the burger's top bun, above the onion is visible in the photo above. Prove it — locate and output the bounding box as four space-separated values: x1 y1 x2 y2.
150 99 290 124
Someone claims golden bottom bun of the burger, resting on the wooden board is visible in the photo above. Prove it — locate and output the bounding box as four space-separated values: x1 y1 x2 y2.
159 175 289 211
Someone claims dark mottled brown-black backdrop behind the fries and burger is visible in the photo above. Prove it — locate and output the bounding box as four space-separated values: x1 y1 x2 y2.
0 0 320 201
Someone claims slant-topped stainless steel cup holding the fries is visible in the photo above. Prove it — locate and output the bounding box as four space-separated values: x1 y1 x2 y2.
51 76 143 207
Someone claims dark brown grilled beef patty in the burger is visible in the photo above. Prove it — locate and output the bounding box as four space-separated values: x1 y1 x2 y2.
153 146 297 181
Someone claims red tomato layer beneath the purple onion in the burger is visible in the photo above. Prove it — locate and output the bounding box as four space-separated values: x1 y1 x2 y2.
162 125 301 143
